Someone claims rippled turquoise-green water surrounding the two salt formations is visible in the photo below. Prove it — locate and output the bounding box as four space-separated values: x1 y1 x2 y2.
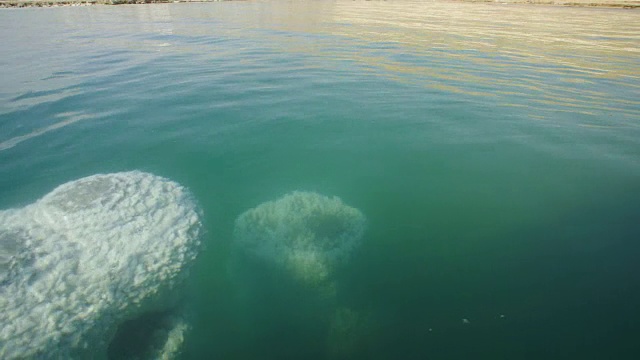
0 1 640 359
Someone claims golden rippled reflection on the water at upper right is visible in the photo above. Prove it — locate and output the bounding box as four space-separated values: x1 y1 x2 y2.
334 2 640 112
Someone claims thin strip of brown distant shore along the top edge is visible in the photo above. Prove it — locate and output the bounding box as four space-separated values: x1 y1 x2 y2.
0 0 640 9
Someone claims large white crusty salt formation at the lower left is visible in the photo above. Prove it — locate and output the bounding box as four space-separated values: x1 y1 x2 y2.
0 171 201 359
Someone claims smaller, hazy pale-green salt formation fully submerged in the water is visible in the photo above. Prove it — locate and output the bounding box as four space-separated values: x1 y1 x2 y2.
234 191 365 285
